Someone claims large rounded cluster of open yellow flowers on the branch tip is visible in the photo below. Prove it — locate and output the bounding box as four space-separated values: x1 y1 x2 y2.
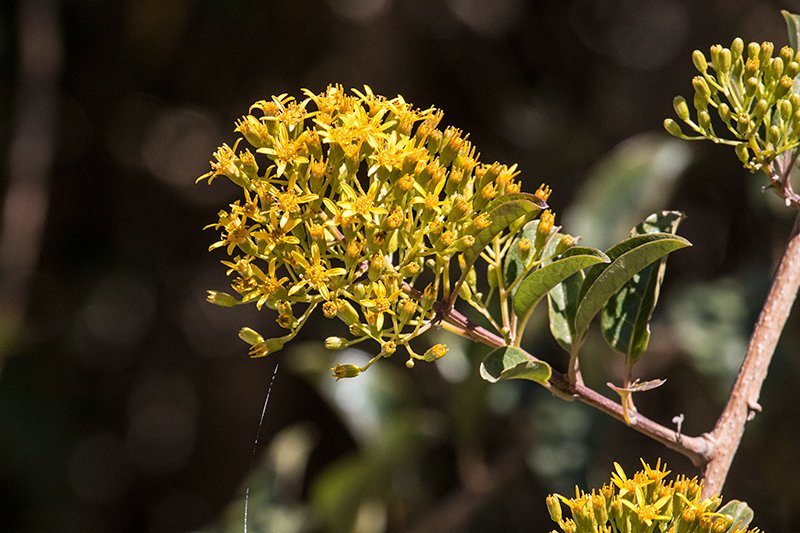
198 85 532 370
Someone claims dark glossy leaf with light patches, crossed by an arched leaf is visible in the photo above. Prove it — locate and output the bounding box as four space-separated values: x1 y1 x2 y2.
600 211 684 365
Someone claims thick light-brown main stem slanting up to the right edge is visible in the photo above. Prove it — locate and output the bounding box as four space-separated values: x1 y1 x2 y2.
703 213 800 496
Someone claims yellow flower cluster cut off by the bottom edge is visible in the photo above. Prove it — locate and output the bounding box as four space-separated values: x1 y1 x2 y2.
547 460 758 533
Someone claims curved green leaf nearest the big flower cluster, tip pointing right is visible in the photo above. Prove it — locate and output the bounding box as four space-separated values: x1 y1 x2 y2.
514 246 611 318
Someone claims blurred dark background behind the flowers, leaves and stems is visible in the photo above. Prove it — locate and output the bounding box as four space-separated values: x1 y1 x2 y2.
0 0 800 533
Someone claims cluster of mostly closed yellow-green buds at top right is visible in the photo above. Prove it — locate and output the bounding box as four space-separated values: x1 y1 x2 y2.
664 38 800 171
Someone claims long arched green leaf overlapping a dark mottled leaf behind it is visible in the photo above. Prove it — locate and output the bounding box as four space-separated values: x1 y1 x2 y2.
575 233 691 336
